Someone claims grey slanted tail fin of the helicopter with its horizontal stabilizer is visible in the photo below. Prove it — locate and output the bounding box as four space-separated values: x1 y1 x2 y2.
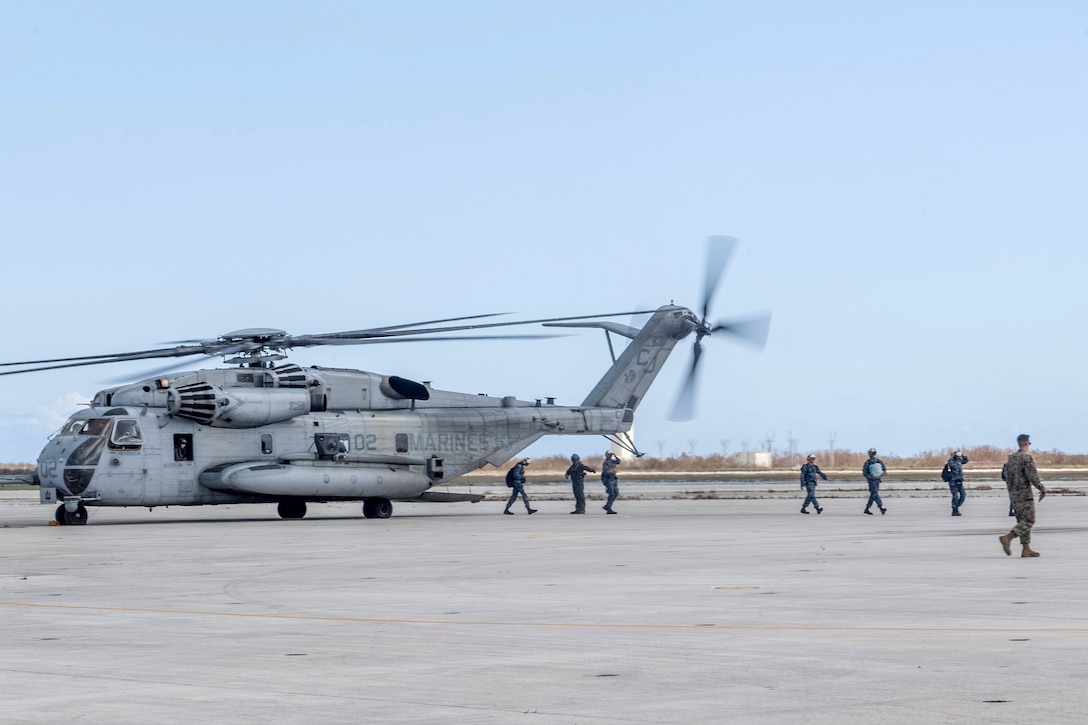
548 305 697 411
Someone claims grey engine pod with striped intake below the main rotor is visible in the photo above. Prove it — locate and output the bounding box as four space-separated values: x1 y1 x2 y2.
166 382 310 428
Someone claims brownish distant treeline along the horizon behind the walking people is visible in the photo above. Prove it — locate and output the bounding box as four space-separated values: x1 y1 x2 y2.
508 445 1088 472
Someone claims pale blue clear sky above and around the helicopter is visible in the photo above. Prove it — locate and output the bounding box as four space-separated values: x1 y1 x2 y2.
0 1 1088 462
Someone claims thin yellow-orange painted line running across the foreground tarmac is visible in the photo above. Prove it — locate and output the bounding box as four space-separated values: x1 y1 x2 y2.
6 602 1088 634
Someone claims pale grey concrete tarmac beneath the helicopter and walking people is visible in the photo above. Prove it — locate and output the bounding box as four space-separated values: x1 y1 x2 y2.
0 487 1088 724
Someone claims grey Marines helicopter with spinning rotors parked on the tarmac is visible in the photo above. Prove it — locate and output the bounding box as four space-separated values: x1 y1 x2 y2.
0 237 770 525
